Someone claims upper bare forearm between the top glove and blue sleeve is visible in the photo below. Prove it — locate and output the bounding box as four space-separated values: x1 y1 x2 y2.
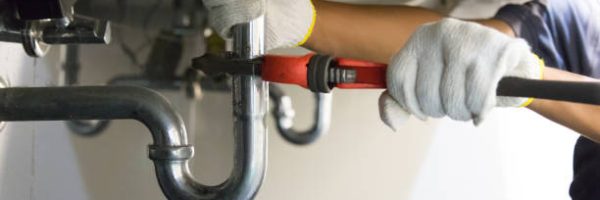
304 1 512 63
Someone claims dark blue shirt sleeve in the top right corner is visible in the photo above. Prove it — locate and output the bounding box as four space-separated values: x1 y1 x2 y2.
495 0 600 78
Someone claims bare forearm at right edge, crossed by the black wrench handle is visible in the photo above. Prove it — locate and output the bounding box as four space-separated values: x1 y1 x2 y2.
529 68 600 142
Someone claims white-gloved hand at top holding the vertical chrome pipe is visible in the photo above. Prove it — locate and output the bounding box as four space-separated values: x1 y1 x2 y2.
203 0 316 50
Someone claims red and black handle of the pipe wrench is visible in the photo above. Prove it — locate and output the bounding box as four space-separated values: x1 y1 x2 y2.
262 54 600 105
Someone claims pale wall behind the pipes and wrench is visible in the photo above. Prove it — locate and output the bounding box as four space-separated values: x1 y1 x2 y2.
0 0 576 200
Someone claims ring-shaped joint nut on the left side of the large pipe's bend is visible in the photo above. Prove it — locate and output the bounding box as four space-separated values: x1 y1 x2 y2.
148 145 194 161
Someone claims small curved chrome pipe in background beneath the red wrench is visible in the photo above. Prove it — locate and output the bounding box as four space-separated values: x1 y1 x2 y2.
269 85 332 145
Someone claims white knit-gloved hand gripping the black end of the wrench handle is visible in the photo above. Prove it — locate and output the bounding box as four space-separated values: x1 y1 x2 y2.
379 19 544 130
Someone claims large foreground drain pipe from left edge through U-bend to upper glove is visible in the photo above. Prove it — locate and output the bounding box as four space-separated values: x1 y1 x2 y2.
0 13 269 200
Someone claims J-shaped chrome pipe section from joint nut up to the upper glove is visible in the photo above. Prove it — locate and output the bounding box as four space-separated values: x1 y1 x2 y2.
150 17 269 200
